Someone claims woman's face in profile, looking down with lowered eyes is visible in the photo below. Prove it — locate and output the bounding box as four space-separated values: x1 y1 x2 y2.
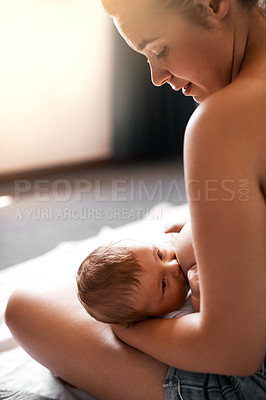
103 0 232 102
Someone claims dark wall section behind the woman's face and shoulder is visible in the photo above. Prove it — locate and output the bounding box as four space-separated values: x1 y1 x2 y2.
112 29 195 159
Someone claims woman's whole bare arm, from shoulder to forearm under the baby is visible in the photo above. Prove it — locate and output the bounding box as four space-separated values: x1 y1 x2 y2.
112 96 266 375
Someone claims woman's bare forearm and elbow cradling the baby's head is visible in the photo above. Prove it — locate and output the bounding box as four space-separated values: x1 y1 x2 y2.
114 313 258 375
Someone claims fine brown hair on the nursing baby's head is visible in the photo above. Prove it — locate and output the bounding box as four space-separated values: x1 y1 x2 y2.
77 240 146 326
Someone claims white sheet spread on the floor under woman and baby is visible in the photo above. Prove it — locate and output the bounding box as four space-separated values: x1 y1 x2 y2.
0 203 189 400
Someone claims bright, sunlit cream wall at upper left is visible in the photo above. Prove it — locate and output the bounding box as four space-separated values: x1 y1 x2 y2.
0 0 112 175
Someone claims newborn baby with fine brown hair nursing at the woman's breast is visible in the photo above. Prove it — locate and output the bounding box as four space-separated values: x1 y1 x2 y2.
77 220 199 326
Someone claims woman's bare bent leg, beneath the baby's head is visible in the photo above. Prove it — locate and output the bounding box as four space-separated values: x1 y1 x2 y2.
6 283 168 400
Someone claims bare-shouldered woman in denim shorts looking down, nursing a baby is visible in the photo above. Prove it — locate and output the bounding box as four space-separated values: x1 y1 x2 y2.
6 0 266 400
